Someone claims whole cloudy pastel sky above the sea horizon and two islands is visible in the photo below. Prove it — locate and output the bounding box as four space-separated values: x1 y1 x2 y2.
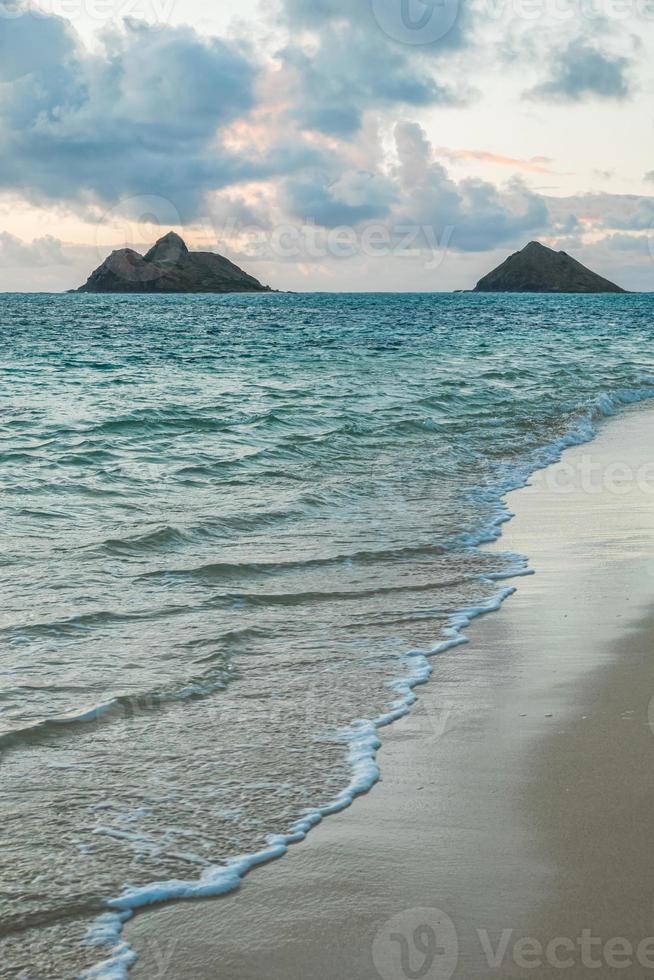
0 0 654 291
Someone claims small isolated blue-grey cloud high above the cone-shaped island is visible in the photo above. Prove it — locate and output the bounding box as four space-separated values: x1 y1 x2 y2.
527 38 631 102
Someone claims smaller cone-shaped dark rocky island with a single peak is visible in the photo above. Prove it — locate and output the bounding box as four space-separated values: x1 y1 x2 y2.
473 242 626 293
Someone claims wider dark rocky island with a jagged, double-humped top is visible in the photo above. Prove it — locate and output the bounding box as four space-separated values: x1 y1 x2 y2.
76 231 272 293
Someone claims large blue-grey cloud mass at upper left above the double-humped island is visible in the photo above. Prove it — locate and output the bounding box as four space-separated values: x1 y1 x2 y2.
0 13 270 213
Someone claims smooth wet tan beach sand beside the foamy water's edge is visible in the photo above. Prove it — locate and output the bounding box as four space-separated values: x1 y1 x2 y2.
125 407 654 980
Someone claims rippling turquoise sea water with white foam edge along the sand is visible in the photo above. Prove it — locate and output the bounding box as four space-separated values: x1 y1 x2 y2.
0 294 654 977
